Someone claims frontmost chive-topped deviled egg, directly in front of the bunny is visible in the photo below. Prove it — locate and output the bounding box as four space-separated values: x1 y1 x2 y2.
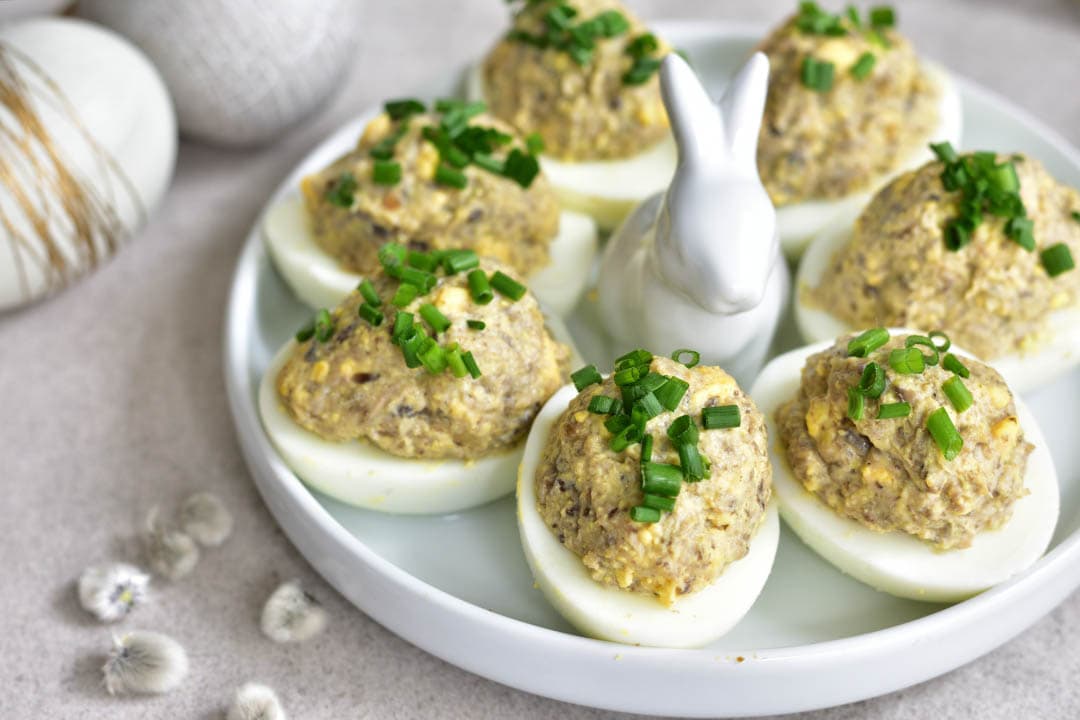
517 350 779 648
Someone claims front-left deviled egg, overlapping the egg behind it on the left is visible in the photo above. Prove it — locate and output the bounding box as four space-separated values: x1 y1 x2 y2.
258 257 580 514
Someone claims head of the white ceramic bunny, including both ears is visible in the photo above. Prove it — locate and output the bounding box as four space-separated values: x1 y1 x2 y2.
652 53 779 314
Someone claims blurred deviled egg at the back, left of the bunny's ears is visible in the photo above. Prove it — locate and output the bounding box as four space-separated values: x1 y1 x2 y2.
468 0 676 230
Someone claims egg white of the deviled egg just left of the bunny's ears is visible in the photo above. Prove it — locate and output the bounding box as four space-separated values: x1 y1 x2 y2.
465 65 678 231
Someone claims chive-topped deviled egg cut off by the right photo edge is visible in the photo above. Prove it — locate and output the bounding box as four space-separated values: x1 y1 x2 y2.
795 145 1080 392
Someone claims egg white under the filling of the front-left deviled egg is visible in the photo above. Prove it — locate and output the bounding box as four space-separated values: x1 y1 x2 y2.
258 316 582 515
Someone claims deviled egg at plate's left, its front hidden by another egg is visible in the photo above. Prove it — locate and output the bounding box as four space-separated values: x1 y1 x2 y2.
264 99 596 315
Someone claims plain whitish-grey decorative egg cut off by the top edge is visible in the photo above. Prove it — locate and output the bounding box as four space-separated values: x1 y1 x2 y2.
79 0 360 146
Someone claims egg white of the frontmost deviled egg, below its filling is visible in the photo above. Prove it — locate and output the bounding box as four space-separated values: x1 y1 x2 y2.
517 385 780 648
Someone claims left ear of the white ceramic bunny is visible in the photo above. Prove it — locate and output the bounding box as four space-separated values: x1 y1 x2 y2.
660 53 727 164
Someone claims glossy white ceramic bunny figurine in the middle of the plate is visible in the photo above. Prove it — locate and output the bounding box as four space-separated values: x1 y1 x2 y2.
599 53 791 384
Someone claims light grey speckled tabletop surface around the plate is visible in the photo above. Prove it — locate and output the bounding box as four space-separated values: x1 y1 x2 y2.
0 0 1080 720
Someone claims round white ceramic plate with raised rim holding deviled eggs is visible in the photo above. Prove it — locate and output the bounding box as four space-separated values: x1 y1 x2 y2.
225 22 1080 717
